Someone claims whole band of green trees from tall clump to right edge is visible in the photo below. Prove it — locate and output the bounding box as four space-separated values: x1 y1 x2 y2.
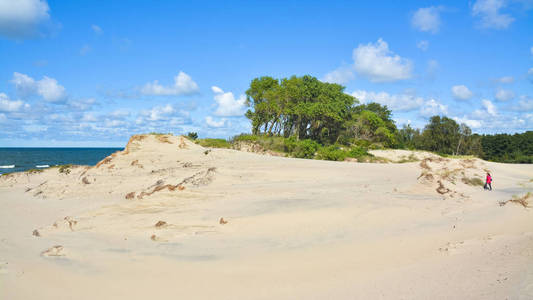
245 75 533 163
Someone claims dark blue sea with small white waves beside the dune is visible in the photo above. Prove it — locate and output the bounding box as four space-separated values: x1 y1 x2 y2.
0 148 122 174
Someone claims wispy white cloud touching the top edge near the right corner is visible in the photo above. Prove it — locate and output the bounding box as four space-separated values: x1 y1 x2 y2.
472 0 514 29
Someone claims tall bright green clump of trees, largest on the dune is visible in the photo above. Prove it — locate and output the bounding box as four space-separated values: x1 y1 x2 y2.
246 75 396 146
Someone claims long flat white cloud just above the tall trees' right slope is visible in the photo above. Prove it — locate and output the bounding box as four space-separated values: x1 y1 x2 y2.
351 90 424 111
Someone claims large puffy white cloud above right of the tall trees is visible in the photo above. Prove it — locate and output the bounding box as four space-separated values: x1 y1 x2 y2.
353 39 412 82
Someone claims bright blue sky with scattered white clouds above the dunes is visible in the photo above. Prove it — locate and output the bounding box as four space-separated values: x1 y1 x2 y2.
0 0 533 147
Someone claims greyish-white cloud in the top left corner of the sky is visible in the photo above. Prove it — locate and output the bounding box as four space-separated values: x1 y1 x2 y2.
0 0 50 39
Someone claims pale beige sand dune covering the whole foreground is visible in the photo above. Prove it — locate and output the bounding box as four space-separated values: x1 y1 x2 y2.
0 136 533 299
